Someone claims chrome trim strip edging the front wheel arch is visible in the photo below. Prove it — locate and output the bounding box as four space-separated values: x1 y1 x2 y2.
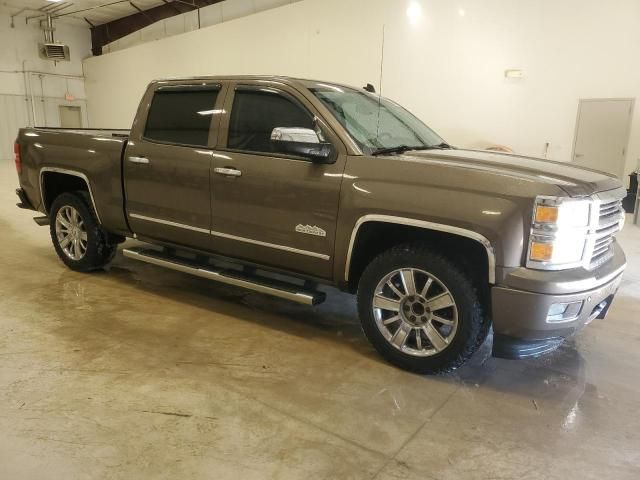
344 214 496 284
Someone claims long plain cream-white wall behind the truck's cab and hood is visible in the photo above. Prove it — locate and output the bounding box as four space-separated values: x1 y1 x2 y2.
84 0 640 179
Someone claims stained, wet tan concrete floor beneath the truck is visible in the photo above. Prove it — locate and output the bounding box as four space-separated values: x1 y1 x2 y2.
0 162 640 480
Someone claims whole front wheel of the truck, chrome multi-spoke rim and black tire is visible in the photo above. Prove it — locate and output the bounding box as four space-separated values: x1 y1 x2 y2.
358 244 489 373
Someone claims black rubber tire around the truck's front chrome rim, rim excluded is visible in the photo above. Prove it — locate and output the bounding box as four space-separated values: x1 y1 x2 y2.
357 243 490 374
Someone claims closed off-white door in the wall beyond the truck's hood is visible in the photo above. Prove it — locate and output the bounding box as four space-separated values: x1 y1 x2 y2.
573 98 633 178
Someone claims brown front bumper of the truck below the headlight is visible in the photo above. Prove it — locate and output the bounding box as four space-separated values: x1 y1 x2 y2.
491 243 626 358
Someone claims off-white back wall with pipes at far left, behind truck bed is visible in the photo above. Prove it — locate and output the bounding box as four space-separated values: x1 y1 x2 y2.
0 10 91 159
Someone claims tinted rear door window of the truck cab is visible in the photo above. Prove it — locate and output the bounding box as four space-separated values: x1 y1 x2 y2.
144 89 218 146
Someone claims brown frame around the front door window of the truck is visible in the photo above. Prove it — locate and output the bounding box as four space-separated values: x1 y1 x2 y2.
216 81 337 159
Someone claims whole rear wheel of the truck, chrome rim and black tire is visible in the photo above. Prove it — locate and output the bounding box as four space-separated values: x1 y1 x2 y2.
49 192 117 272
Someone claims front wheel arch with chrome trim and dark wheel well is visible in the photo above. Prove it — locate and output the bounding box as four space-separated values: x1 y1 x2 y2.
344 215 496 292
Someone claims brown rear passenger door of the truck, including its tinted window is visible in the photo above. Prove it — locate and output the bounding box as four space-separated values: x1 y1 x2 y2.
123 81 225 249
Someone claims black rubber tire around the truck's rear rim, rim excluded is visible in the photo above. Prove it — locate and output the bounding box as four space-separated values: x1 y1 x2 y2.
49 192 118 272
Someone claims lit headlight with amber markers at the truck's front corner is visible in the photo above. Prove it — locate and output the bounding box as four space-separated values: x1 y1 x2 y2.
527 196 593 270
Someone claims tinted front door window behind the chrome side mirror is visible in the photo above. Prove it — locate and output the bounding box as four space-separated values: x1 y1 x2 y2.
227 90 314 153
